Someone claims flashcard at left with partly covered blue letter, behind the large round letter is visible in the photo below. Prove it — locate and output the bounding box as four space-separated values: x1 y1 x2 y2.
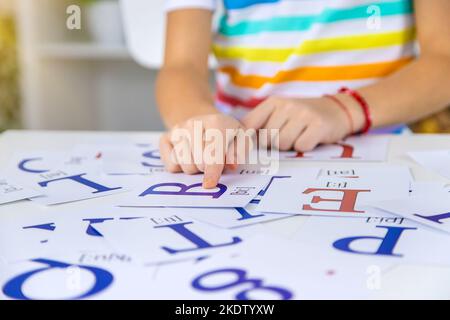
0 207 174 261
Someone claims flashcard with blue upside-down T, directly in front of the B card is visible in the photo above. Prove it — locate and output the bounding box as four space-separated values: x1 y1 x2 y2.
95 208 264 265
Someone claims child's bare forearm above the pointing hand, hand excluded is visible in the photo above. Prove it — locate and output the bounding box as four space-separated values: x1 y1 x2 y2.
156 9 217 128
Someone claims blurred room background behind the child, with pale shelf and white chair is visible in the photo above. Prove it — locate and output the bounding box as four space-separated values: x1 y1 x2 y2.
0 0 450 133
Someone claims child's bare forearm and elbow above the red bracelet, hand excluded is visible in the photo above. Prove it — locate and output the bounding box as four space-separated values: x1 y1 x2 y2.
360 0 450 126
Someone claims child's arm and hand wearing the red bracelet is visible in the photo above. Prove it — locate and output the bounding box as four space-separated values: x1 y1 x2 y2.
243 0 450 151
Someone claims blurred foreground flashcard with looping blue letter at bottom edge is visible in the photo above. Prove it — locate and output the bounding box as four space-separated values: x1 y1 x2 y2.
154 236 371 300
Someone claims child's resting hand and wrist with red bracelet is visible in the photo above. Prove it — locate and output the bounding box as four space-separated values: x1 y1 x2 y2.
242 96 364 152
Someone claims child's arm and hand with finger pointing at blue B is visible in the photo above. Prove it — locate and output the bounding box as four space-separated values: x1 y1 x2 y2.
157 9 244 188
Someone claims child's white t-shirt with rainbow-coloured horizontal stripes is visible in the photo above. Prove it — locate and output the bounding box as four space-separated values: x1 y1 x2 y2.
167 0 415 116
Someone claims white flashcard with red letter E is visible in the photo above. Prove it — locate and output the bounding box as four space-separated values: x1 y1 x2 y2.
257 170 410 217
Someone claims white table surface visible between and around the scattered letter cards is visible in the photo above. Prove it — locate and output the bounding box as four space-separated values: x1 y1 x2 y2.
0 131 450 299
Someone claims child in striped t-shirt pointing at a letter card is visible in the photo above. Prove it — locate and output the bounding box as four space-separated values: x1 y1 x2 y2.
157 0 450 188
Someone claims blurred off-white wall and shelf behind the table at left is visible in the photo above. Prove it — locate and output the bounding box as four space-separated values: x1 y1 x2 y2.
15 0 206 130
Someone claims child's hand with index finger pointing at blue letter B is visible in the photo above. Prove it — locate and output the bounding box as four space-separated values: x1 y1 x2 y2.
160 114 242 189
